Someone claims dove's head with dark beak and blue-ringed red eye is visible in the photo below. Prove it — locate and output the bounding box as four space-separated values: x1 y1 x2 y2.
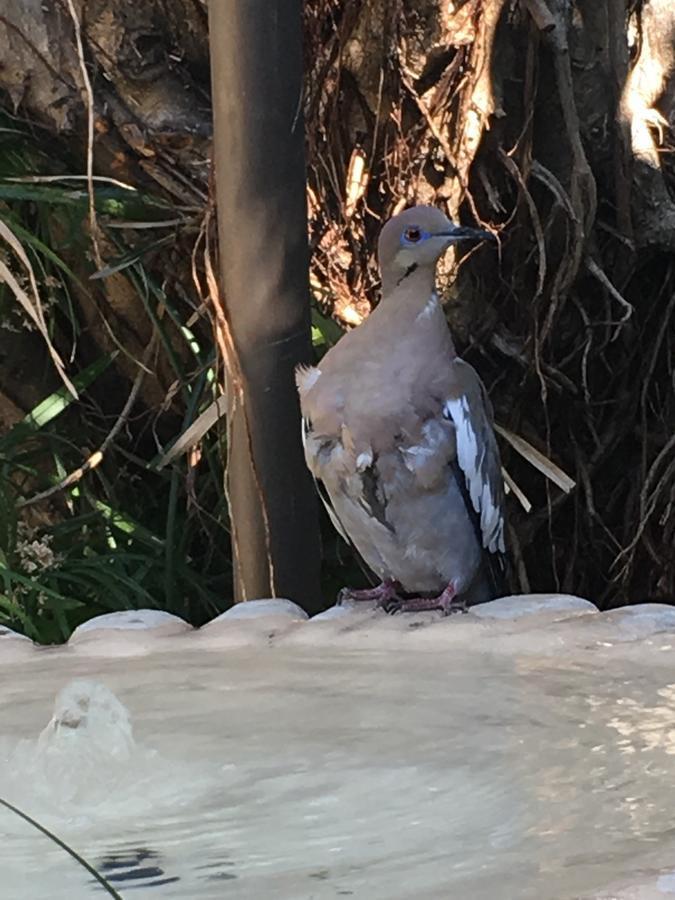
378 206 494 284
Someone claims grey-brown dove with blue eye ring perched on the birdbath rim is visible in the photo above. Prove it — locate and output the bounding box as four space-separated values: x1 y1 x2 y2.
295 206 506 615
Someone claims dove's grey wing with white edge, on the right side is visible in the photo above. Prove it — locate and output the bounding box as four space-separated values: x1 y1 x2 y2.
443 359 506 554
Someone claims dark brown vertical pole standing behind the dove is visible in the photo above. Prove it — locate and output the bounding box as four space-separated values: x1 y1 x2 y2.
209 0 320 611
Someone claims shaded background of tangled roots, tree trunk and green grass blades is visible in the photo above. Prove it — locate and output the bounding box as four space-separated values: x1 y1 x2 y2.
0 0 675 640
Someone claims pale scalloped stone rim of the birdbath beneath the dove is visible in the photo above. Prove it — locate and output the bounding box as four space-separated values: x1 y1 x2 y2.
0 594 675 663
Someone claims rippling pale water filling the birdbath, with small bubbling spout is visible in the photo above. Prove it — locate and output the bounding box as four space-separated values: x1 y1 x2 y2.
0 596 675 900
